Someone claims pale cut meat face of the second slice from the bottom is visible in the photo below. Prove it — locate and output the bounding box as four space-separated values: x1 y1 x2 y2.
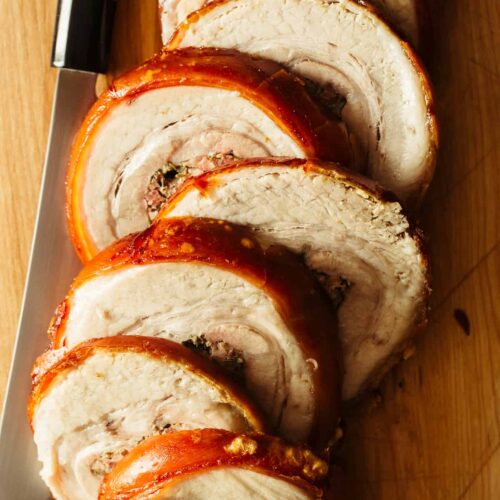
33 351 250 500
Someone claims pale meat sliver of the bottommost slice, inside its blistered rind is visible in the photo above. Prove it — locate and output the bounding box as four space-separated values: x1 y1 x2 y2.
159 467 314 500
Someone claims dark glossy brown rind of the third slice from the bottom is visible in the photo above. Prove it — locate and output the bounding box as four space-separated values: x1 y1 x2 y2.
49 217 342 450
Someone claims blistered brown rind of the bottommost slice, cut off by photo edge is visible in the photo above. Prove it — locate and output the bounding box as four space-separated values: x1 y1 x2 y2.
99 429 328 500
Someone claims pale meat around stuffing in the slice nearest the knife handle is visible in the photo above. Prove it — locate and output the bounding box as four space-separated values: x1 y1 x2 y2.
82 86 304 249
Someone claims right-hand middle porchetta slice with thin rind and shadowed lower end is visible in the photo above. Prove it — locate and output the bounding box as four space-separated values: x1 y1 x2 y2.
159 159 428 399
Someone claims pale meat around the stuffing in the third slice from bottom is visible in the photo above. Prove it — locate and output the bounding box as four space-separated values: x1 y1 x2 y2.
61 262 312 440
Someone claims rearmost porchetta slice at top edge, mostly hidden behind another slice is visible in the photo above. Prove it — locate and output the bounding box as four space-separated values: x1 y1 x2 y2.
159 0 423 47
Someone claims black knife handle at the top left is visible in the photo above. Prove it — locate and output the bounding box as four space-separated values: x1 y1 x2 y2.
52 0 116 73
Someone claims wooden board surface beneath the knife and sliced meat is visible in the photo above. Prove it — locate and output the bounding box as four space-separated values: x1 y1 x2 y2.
0 0 500 500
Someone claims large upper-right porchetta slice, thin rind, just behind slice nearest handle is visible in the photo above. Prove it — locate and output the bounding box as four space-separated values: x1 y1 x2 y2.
168 0 437 207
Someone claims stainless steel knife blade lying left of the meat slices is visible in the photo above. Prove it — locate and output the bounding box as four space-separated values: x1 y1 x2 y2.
0 69 96 500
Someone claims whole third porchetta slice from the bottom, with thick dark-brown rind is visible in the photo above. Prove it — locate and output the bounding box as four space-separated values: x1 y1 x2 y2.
50 218 341 449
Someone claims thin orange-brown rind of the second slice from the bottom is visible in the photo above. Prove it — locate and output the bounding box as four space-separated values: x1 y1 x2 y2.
28 335 267 431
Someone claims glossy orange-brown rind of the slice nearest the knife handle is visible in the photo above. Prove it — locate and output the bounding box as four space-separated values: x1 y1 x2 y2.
66 48 351 262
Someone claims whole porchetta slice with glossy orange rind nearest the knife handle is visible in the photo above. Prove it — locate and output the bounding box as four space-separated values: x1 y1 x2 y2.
67 49 350 261
